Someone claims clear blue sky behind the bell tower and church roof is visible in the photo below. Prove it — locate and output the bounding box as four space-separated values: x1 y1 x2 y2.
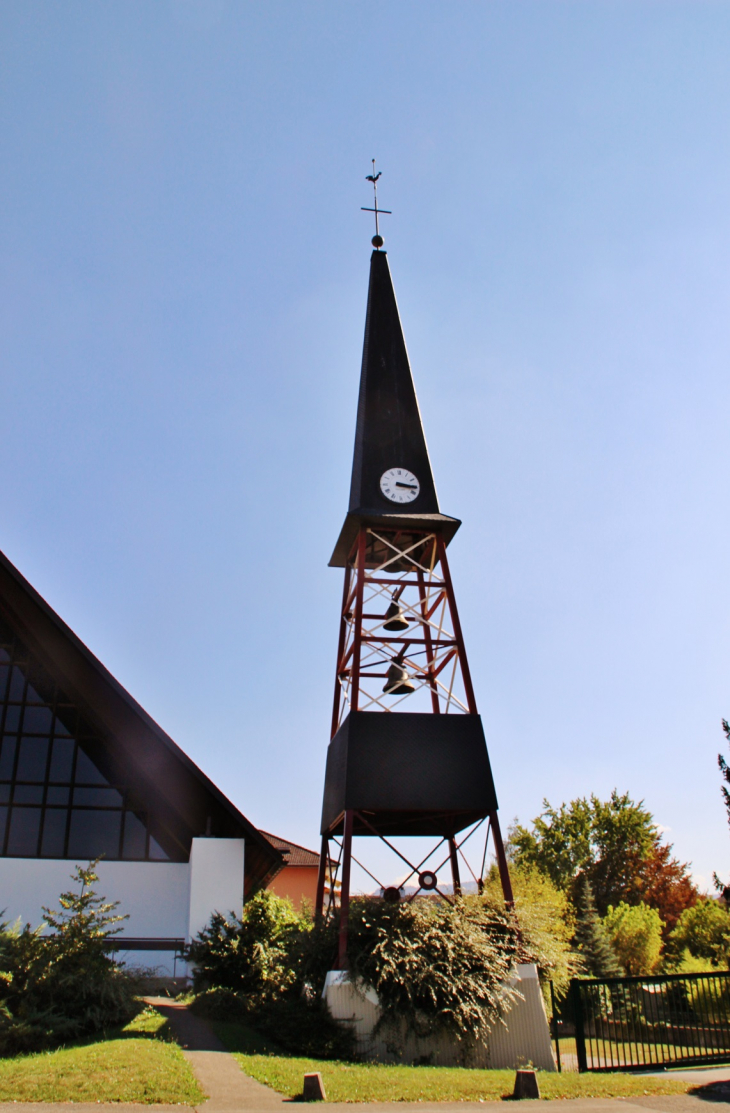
0 0 730 883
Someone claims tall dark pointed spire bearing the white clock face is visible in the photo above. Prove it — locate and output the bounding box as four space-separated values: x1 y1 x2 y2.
349 250 438 515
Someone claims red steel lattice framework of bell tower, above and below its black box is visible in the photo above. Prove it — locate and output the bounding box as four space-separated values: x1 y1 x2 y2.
316 525 513 968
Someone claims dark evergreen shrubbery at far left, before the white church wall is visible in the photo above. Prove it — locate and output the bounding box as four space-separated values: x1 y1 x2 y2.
0 863 137 1055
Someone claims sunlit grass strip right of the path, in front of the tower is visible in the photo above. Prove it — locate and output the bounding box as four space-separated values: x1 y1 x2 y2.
215 1024 691 1102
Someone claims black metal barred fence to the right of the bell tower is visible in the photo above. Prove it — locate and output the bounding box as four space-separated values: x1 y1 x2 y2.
570 972 730 1071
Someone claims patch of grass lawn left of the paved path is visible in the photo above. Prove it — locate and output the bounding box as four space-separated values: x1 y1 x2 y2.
0 1008 206 1105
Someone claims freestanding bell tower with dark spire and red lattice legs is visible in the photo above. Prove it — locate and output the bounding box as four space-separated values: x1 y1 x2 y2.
316 195 512 969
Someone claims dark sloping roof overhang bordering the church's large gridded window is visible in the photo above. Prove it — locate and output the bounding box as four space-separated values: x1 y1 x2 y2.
0 553 284 896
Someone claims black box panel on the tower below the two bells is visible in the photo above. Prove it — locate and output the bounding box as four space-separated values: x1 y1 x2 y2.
322 711 497 837
